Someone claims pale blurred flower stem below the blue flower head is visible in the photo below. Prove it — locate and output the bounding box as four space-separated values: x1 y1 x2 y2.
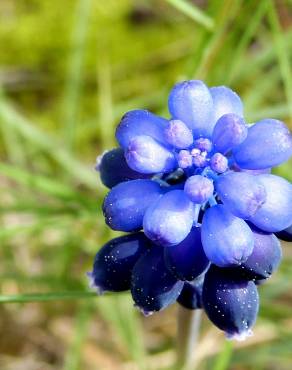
176 305 202 370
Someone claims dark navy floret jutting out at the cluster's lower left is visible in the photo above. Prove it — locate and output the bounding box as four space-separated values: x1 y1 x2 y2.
88 233 149 294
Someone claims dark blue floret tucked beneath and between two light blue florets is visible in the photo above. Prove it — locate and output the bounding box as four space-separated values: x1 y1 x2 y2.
164 227 210 281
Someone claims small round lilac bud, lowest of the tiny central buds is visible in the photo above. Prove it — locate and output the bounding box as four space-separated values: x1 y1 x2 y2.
184 175 214 204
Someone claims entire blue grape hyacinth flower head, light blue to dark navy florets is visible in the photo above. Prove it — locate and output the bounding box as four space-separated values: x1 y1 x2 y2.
89 80 292 339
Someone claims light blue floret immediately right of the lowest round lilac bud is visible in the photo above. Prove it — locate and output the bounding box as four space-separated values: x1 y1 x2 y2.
215 172 267 219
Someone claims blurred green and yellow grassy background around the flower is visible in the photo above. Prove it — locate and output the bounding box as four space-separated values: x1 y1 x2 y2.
0 0 292 370
